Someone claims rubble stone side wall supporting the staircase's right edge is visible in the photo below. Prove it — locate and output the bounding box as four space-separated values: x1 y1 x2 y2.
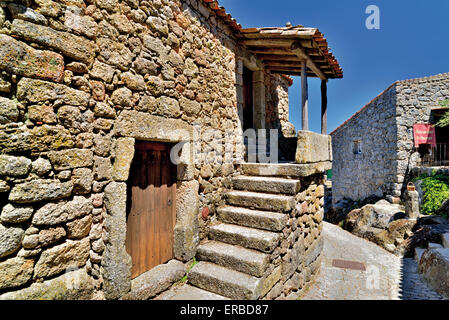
262 174 324 300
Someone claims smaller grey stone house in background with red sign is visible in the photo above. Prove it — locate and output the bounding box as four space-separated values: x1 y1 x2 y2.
331 73 449 204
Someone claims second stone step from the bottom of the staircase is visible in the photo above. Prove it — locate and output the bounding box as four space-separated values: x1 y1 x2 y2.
197 241 270 277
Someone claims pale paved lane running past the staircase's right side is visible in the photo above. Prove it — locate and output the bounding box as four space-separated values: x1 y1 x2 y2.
302 223 441 300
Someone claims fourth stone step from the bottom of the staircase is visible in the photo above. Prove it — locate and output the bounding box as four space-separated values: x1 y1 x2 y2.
217 206 288 231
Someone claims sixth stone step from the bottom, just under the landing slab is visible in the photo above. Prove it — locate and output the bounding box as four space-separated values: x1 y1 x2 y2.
232 176 301 195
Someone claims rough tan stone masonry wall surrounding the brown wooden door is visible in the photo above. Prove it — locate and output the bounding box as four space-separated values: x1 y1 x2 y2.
0 0 322 299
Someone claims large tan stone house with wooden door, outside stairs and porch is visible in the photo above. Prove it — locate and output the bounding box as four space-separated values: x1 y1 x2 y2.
0 0 342 299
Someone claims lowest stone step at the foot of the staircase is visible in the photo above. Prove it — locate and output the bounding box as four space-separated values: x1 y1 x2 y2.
188 261 262 300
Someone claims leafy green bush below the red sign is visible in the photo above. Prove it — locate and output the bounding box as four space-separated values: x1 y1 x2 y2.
414 174 449 215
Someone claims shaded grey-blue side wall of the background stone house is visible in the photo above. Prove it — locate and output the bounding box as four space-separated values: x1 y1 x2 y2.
332 86 397 204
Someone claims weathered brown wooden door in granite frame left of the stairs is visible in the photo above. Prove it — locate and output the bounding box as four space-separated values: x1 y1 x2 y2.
126 142 176 279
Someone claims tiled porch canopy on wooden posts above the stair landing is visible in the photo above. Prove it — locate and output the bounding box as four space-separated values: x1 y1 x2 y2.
237 26 343 134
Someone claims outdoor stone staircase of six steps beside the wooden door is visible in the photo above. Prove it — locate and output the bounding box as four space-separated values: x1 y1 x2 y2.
188 164 300 300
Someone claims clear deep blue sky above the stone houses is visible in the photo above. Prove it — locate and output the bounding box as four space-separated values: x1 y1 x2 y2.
219 0 449 132
